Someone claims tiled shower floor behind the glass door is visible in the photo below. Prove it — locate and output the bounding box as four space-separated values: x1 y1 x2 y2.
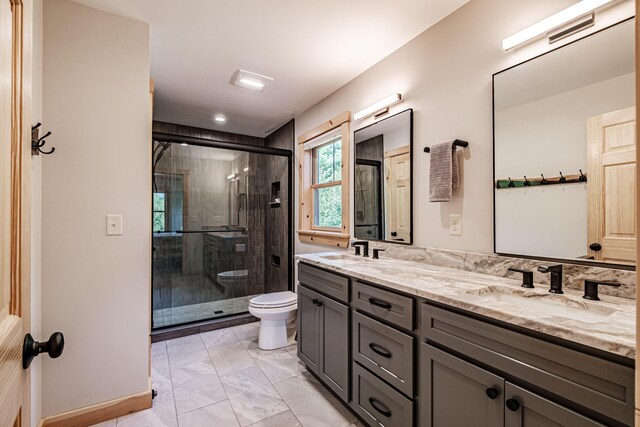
153 295 257 328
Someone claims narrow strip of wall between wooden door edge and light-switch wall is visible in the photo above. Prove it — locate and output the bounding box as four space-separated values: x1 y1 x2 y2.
30 0 42 426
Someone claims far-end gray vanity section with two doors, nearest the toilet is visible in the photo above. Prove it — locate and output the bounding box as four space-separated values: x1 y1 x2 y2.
298 264 350 402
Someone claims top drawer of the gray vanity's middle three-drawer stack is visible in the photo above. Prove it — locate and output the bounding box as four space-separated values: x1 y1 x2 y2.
352 282 414 331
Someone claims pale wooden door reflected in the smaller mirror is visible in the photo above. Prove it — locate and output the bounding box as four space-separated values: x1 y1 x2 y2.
384 145 411 242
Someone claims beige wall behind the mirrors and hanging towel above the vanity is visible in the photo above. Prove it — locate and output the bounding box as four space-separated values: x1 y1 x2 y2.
296 0 634 253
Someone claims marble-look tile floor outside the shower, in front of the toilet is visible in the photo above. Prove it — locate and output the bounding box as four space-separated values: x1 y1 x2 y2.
98 323 363 427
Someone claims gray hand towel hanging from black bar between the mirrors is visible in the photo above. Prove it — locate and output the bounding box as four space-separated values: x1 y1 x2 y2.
429 141 460 202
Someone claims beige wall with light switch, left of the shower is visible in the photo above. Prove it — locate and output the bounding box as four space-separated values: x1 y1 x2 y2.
41 0 151 416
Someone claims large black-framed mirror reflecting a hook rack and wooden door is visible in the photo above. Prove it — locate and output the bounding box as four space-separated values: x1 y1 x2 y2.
493 20 636 265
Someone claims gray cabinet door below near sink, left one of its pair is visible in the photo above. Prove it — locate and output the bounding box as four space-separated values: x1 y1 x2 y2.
420 344 504 427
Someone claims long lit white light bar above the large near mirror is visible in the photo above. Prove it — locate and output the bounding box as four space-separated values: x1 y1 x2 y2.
502 0 615 50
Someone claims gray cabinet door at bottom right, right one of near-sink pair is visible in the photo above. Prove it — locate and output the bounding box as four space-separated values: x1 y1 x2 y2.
504 382 604 427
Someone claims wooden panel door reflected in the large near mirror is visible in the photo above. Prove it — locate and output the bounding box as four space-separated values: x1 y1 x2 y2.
587 107 636 264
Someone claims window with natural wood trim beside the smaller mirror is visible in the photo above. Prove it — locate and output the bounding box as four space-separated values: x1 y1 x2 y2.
298 112 351 247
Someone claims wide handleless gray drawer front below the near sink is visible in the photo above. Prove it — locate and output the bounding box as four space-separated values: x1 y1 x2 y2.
420 304 634 425
